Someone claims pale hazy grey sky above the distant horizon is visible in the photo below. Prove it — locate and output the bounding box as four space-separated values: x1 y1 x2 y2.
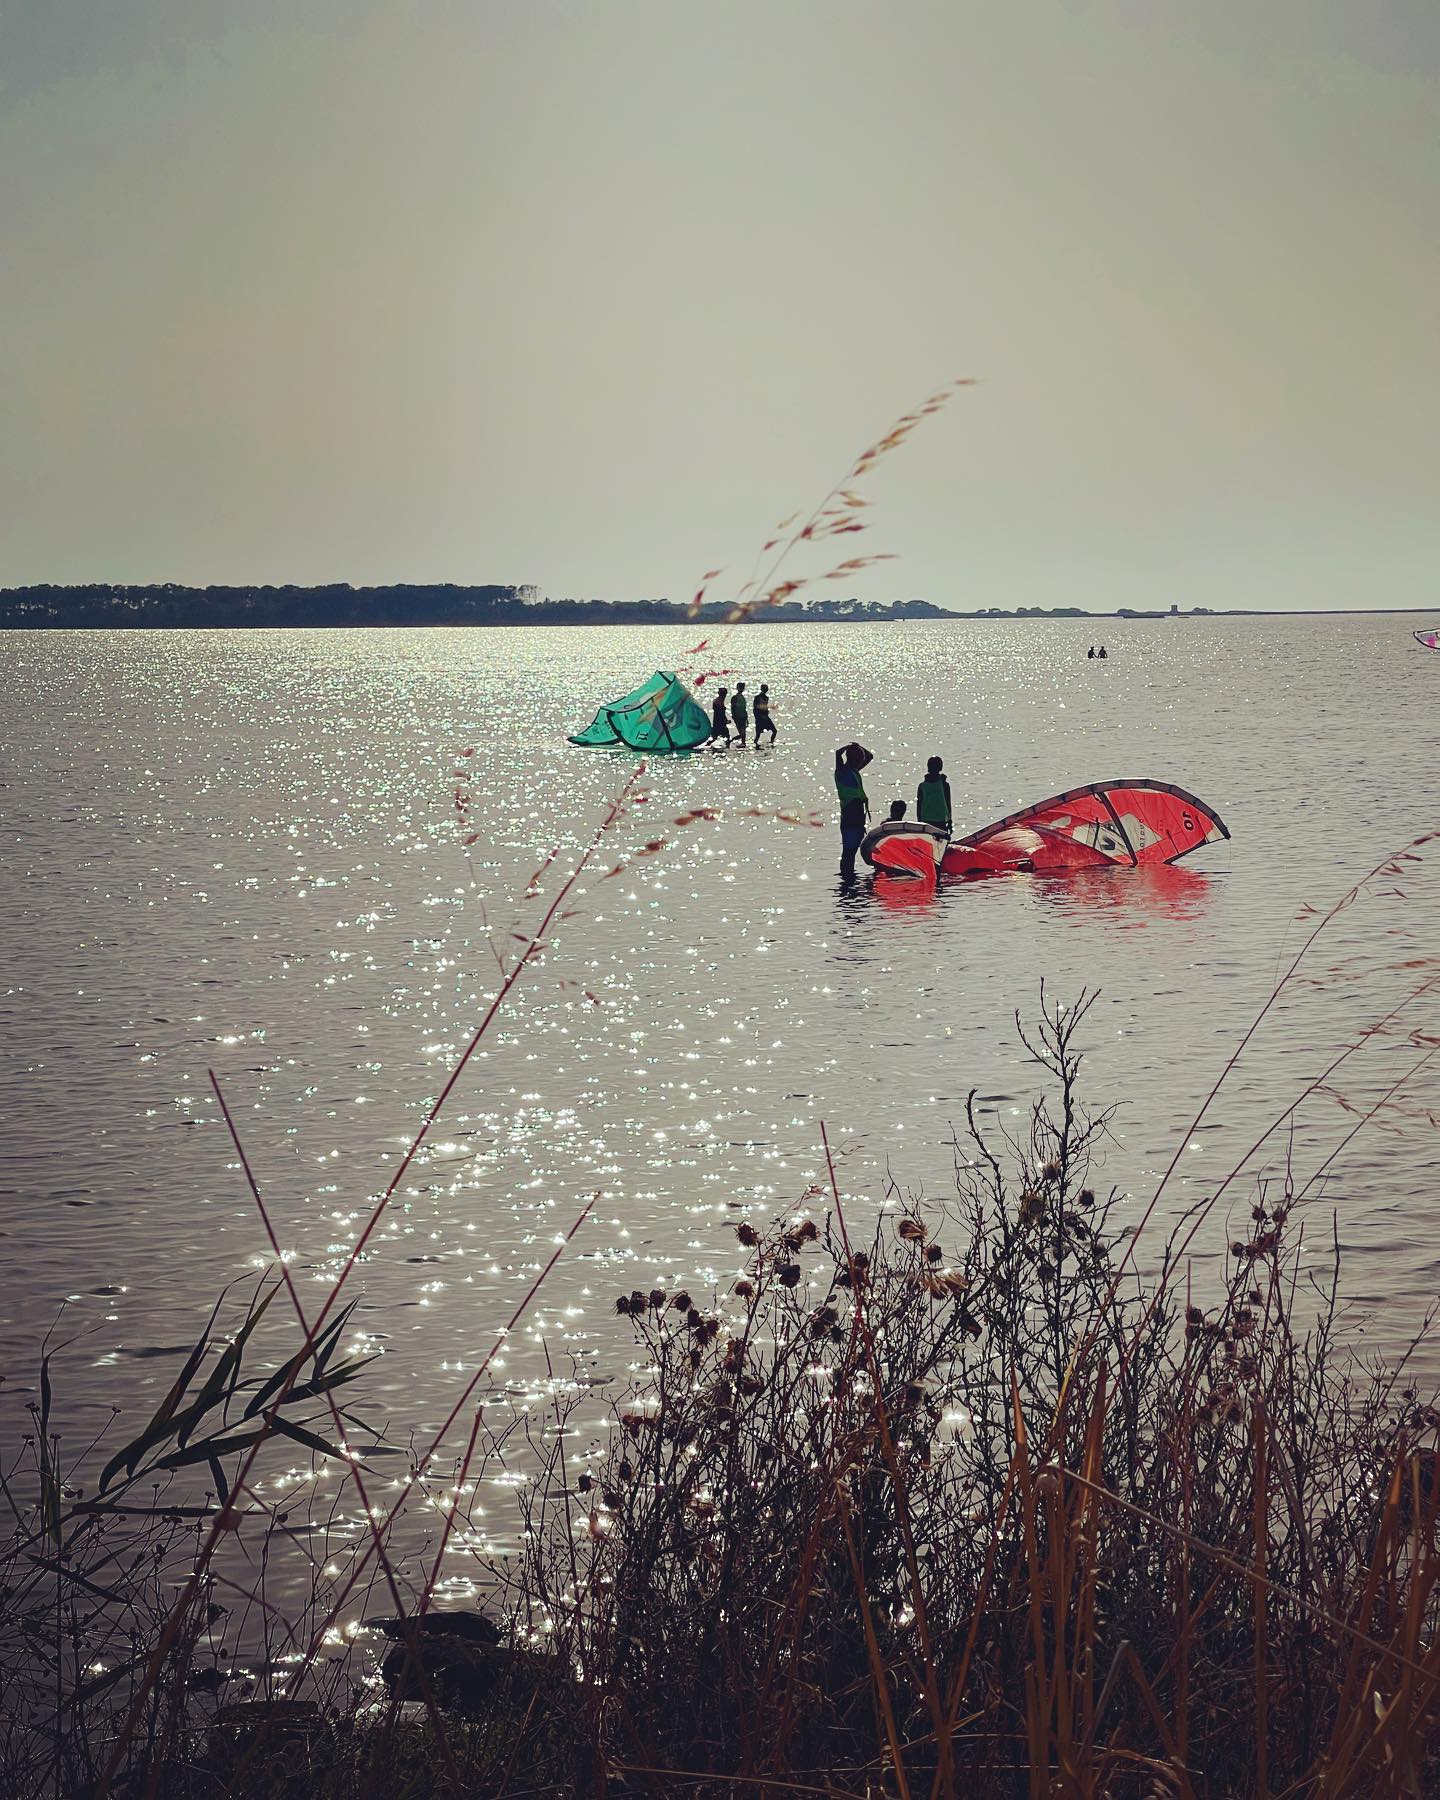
0 0 1440 607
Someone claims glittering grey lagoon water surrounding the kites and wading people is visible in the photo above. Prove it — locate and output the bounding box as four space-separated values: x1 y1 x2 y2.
0 617 1440 1504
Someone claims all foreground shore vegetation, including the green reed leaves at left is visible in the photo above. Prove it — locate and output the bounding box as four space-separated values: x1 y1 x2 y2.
0 1003 1440 1800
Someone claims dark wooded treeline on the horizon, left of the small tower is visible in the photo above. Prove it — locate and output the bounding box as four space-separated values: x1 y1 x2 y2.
0 581 954 630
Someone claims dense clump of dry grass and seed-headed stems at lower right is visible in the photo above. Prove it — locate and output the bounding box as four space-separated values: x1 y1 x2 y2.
486 1003 1440 1796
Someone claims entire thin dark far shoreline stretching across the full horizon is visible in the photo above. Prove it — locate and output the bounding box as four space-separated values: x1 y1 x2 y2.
0 583 1440 632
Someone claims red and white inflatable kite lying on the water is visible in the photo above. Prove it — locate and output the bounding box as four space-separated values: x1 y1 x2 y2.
860 781 1229 882
